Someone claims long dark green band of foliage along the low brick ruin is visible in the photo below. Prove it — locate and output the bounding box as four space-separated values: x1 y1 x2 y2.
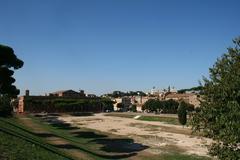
25 97 113 112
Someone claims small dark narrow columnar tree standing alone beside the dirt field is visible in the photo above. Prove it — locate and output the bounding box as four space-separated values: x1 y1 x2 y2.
178 101 188 126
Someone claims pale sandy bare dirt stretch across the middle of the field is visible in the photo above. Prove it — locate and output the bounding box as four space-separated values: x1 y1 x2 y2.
58 113 211 156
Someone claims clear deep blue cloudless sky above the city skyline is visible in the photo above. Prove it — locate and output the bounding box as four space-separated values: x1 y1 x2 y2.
0 0 240 95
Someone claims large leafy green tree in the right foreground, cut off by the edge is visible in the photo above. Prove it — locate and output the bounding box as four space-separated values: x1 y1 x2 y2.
192 37 240 160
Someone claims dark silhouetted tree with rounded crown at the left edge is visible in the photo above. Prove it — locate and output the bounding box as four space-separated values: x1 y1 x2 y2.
0 45 23 115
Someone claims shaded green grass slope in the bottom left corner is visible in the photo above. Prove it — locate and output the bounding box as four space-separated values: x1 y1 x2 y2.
0 118 71 160
